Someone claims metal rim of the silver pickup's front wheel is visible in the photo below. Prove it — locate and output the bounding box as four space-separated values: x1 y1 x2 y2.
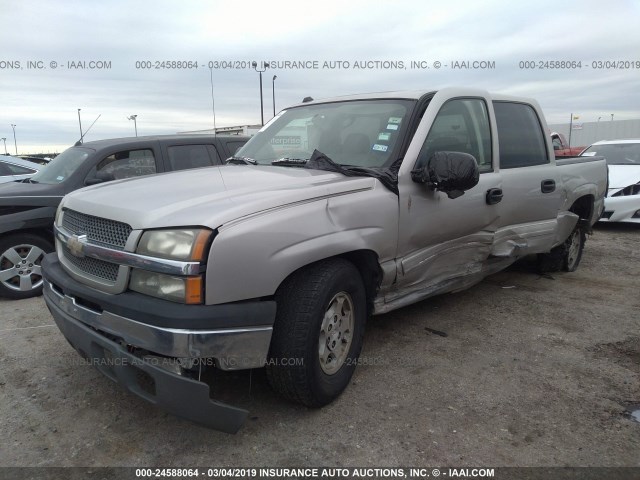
318 292 355 375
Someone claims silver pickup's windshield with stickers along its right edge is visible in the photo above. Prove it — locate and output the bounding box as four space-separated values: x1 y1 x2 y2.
236 100 415 168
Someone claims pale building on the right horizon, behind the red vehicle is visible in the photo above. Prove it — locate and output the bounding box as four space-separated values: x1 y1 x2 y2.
549 117 640 147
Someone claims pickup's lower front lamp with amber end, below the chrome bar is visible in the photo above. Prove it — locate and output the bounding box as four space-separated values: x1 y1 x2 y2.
129 268 203 304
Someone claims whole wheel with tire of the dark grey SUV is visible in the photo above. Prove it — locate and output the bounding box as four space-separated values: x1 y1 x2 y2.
0 233 53 299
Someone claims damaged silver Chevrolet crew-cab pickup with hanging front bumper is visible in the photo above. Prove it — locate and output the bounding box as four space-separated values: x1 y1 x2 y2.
42 89 607 432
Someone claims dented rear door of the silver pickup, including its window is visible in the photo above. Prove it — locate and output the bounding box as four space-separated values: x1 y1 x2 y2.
493 101 561 256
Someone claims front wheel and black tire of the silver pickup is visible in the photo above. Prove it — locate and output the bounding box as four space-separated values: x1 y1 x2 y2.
267 258 367 407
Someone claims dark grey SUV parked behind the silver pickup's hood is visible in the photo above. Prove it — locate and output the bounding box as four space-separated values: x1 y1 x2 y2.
0 135 248 299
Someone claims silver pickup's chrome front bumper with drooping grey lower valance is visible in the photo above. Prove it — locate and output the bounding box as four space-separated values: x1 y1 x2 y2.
43 254 275 433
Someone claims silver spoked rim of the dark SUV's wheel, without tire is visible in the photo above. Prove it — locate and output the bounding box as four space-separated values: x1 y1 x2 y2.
0 244 45 292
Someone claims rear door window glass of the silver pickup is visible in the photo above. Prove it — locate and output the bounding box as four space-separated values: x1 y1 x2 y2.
493 102 549 168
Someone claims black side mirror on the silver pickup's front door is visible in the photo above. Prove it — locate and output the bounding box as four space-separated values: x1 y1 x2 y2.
411 152 480 198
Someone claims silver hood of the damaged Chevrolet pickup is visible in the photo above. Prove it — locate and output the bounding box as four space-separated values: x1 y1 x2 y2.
63 165 383 229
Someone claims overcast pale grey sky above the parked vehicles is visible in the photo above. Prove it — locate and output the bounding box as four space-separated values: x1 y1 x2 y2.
0 0 640 154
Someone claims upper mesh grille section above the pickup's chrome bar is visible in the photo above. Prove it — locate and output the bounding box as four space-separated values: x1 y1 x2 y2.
62 209 132 250
